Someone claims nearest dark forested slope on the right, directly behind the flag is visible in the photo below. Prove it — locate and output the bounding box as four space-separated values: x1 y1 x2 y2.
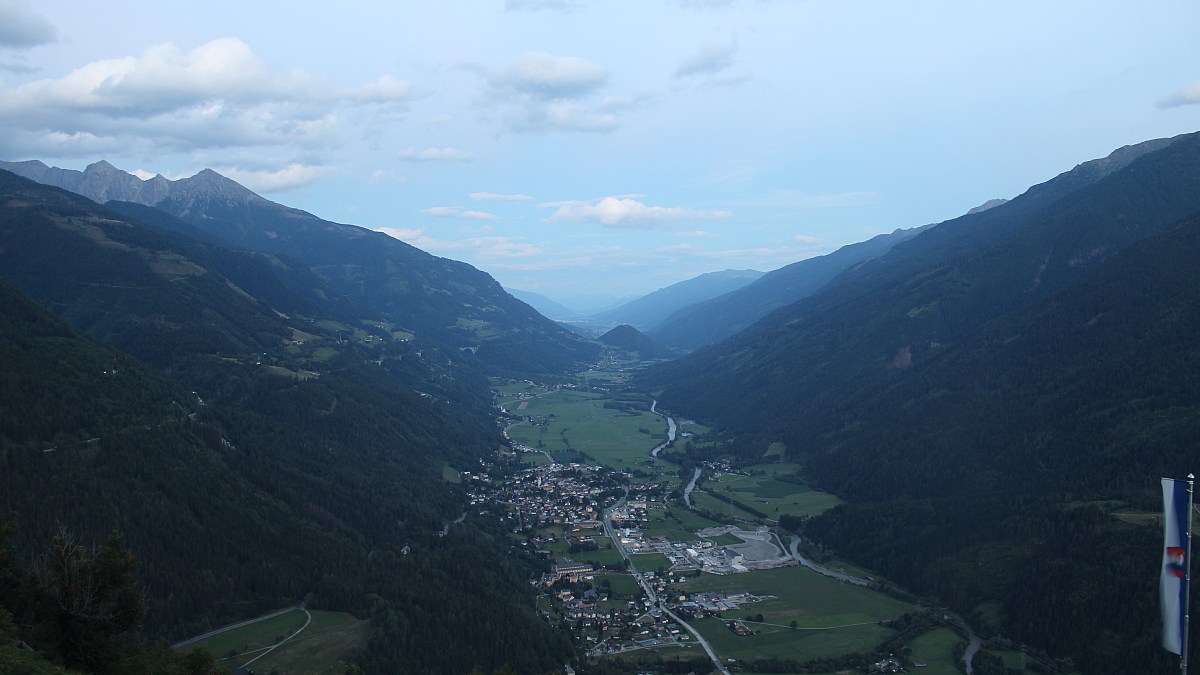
804 215 1200 674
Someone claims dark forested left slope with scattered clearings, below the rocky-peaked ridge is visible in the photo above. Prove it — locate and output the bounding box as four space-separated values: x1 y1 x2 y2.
0 175 570 671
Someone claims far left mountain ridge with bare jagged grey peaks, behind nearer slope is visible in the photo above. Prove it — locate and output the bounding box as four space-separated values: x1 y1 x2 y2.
0 161 598 372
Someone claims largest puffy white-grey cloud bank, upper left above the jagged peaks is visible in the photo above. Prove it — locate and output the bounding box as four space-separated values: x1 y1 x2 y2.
0 37 410 156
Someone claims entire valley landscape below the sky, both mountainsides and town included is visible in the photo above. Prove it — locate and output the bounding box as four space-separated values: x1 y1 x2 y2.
0 135 1200 675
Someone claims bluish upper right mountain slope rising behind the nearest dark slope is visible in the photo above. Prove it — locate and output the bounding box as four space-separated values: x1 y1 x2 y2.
642 136 1200 443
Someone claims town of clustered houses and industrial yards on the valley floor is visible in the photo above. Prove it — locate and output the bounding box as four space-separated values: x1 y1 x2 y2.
463 448 796 655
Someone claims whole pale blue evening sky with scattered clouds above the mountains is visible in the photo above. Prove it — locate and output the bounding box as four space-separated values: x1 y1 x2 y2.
0 0 1200 300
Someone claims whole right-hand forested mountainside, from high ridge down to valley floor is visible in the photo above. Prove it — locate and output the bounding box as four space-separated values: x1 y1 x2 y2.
643 135 1200 675
